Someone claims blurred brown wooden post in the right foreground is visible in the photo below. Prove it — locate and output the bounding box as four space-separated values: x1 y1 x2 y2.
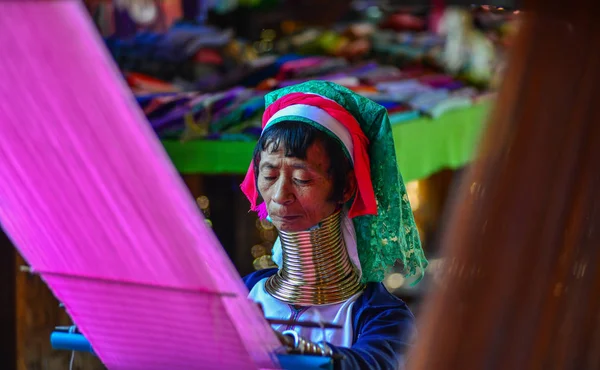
409 0 600 370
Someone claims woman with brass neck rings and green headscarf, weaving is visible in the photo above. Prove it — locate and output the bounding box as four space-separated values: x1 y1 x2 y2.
242 81 427 369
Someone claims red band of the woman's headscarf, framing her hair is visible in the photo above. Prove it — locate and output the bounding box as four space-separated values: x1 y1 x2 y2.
241 93 377 218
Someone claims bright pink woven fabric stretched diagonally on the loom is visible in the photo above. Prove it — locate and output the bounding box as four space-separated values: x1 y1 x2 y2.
0 0 279 370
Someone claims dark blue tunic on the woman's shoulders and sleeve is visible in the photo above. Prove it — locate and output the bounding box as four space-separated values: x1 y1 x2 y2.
244 269 415 370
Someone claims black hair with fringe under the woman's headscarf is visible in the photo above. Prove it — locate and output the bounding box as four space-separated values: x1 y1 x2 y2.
252 121 352 203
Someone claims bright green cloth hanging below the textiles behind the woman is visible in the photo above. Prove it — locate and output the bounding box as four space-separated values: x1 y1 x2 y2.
163 104 489 181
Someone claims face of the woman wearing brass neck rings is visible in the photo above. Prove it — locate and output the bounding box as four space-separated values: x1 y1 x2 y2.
258 141 346 231
